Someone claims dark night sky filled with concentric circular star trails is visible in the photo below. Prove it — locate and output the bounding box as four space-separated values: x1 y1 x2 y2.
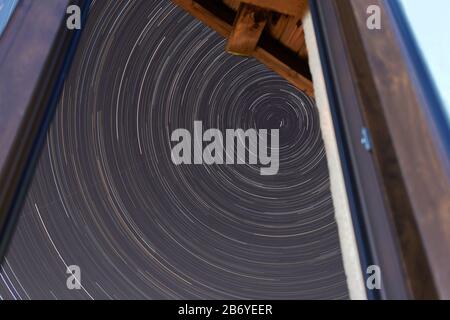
0 1 348 299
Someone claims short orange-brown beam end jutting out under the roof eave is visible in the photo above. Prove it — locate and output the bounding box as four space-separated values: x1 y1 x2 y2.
226 3 267 56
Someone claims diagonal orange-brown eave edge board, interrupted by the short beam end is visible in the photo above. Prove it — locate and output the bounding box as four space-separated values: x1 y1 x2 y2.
172 0 314 97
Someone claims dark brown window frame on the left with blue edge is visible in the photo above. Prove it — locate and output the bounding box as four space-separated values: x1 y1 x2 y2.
0 0 91 263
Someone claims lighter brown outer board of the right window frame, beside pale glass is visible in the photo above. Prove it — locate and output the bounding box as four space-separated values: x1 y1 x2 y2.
350 0 450 299
